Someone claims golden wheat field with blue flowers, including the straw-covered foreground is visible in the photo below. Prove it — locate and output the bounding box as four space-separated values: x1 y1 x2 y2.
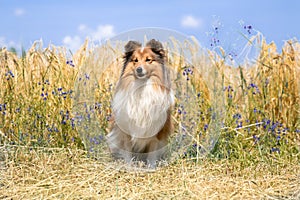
0 34 300 199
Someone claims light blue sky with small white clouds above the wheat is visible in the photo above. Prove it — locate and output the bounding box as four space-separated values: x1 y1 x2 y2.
0 0 300 52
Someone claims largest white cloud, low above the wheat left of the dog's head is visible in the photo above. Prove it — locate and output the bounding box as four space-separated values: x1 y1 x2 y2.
62 24 115 51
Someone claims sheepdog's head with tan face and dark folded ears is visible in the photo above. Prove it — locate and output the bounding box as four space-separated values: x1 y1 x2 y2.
122 39 165 79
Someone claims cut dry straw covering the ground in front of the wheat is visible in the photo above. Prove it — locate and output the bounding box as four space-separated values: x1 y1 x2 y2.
0 146 300 199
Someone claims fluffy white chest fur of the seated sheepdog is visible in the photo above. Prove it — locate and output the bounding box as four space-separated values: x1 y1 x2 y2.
112 79 173 138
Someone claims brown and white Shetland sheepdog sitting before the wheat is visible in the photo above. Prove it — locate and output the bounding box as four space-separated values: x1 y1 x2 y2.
107 39 174 168
